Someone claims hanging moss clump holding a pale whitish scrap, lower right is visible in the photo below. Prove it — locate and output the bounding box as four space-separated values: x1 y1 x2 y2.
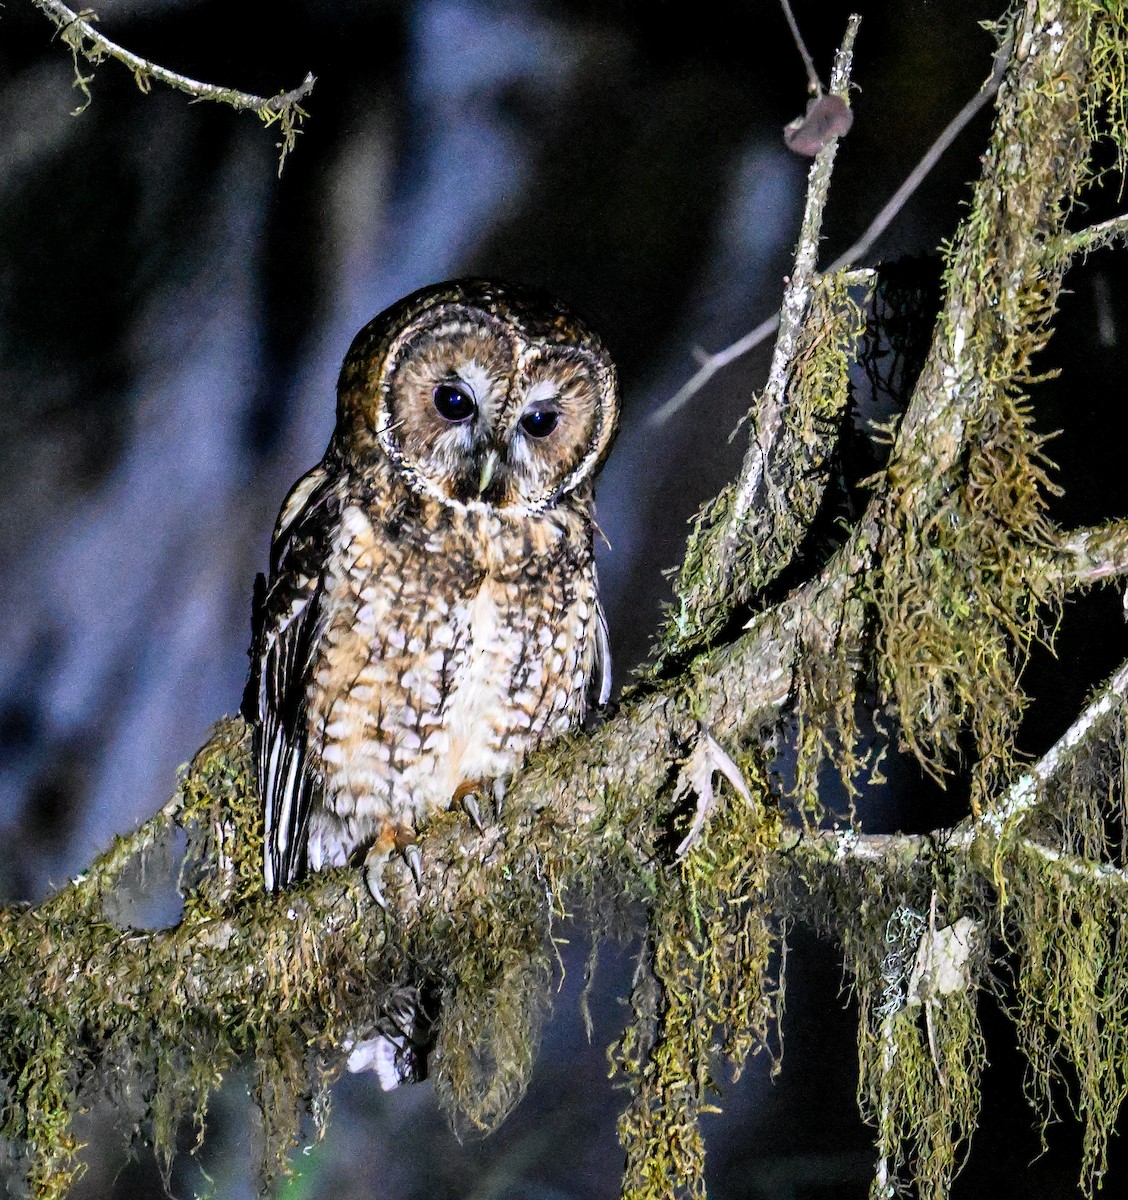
776 844 997 1200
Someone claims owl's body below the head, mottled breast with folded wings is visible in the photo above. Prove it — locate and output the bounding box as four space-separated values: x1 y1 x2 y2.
248 461 610 888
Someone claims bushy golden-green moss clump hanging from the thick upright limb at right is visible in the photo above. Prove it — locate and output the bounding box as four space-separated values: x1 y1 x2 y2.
874 364 1057 808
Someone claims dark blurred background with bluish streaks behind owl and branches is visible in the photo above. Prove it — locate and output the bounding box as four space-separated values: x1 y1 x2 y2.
0 0 1128 1200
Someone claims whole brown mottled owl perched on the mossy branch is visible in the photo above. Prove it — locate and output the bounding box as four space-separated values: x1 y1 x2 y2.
245 280 618 902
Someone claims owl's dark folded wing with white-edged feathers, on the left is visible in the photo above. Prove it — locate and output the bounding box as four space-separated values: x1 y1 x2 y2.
245 468 337 892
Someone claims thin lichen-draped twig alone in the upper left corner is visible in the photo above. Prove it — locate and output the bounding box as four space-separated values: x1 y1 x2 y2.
32 0 317 174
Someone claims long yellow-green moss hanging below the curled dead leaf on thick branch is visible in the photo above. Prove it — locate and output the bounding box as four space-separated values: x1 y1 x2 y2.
611 772 782 1200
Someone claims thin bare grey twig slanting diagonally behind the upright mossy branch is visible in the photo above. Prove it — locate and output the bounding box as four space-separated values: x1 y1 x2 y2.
649 44 1010 425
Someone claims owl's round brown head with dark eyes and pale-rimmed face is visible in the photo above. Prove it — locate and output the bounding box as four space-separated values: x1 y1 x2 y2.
337 280 619 511
